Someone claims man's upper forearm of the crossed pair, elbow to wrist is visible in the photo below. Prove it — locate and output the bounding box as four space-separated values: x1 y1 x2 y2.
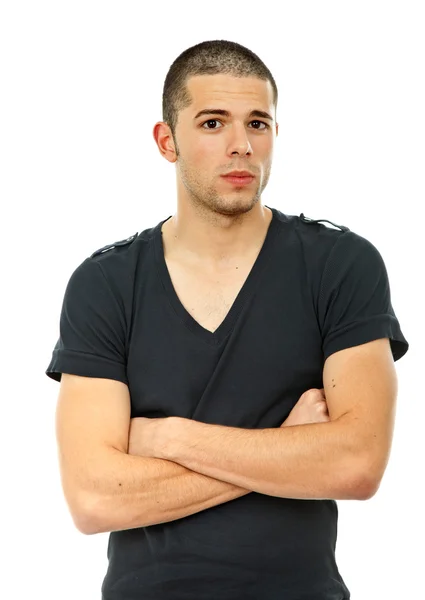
159 419 368 499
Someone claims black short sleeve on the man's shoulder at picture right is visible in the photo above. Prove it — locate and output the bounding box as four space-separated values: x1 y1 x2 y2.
318 231 409 361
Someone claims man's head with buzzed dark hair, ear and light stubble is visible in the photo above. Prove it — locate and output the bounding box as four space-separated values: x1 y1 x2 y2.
154 40 278 220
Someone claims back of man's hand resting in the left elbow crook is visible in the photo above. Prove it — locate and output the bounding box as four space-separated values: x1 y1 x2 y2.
127 417 175 458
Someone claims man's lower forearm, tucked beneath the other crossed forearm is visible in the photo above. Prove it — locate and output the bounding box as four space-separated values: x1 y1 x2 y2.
85 448 251 533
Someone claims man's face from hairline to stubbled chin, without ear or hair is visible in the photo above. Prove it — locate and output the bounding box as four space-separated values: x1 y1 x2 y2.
171 74 277 215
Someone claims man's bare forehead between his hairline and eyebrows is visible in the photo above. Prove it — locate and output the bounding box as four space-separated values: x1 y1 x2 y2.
186 73 273 112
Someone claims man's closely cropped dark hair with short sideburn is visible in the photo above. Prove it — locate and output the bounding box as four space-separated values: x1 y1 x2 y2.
162 40 278 138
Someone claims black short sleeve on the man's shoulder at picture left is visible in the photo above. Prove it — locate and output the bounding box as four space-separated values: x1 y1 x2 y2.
46 258 128 385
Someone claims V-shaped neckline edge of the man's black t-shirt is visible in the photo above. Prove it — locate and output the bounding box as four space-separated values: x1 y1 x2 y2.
153 205 278 346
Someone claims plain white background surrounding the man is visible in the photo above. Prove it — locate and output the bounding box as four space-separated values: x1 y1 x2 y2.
0 0 425 600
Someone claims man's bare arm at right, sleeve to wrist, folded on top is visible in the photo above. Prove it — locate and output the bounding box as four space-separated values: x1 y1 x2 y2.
157 338 397 499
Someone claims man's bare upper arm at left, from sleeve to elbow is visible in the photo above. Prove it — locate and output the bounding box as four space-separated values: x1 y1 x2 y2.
56 373 130 521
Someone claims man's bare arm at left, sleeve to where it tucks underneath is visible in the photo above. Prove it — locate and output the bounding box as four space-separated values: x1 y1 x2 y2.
56 373 251 534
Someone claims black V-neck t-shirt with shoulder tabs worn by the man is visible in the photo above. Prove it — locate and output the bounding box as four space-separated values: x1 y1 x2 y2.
46 208 408 600
